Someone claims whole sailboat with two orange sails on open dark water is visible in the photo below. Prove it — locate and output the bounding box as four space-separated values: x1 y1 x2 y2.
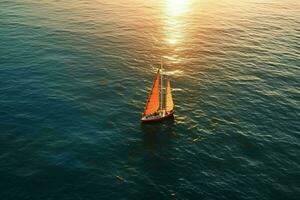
141 64 174 122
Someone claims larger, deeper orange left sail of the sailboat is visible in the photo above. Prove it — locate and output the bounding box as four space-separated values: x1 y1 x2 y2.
144 71 159 115
